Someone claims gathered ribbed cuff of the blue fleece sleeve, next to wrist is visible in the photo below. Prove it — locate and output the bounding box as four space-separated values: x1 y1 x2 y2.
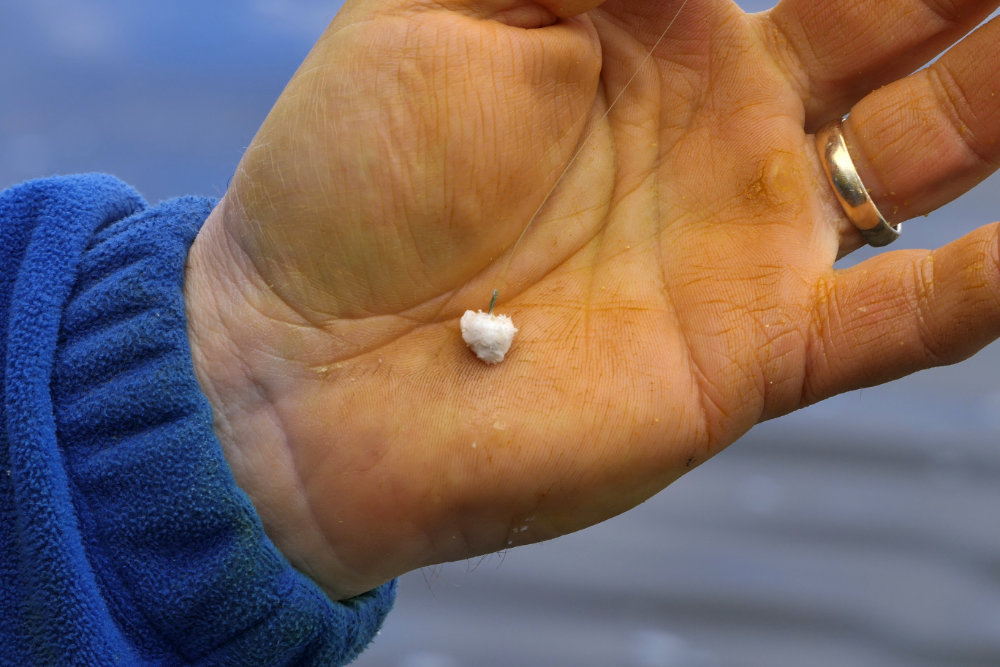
4 176 395 665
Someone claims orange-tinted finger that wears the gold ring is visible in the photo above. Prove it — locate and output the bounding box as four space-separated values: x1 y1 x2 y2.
804 17 1000 254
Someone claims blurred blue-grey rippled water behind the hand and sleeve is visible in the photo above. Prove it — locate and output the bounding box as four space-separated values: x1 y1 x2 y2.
0 0 1000 667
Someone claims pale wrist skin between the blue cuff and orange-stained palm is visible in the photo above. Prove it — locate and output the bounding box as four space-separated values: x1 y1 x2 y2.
184 199 378 599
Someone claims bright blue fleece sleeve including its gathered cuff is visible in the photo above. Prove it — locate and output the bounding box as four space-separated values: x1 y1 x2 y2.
0 175 395 666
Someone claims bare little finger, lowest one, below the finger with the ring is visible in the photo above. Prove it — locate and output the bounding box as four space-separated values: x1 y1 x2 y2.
803 223 1000 404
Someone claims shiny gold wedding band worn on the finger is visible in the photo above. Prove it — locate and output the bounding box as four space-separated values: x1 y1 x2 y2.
816 120 902 247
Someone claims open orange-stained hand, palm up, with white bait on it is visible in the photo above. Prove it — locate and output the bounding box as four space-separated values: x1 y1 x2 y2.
186 0 1000 597
